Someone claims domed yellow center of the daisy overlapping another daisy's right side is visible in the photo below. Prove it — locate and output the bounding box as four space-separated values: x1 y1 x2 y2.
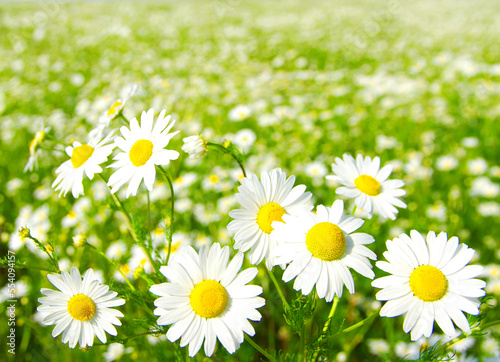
306 222 345 261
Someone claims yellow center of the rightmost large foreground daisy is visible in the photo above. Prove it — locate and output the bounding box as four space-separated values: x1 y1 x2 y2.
410 265 448 302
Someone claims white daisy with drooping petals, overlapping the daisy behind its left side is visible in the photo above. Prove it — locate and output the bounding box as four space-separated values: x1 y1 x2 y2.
272 200 377 302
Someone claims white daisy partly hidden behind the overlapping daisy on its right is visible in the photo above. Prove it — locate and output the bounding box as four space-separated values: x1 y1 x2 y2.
227 168 312 270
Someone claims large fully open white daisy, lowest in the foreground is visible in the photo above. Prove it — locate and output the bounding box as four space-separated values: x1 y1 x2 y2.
150 243 265 357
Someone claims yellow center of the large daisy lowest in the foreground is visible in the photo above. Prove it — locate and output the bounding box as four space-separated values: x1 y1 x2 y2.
189 280 228 318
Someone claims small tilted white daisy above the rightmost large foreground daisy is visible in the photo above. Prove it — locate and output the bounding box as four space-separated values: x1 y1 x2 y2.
326 153 406 220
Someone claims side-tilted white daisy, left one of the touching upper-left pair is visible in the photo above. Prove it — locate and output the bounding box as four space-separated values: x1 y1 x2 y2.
52 132 115 198
